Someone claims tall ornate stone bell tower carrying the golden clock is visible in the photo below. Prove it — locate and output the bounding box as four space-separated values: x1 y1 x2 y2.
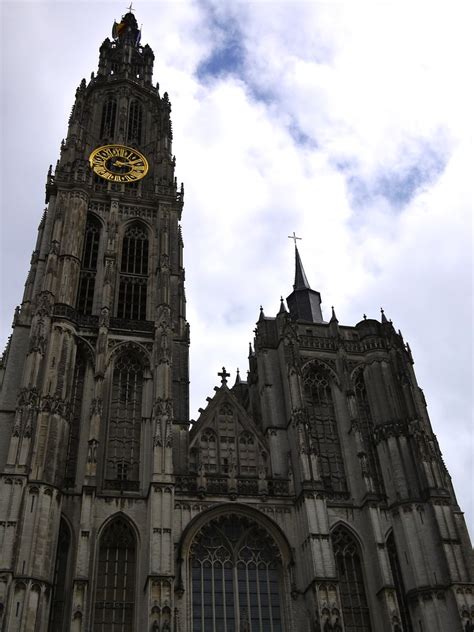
0 12 189 632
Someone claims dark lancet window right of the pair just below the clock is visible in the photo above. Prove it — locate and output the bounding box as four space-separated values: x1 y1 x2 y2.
117 222 148 320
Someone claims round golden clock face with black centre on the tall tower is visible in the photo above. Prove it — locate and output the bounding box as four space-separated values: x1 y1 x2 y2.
89 145 148 182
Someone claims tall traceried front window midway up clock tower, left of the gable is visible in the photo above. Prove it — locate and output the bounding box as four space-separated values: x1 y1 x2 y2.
105 354 143 490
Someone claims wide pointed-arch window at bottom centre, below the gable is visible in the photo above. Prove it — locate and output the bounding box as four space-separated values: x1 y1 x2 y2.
190 515 284 632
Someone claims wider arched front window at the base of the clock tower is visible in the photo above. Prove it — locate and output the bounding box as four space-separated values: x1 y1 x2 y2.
92 518 137 632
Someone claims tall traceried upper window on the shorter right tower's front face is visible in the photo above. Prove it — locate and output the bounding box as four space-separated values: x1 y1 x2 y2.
304 367 347 492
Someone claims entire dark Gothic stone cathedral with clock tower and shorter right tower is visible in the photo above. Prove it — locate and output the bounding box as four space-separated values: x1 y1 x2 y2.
0 11 474 632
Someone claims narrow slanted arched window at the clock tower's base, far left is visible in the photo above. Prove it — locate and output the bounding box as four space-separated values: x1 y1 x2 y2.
49 518 71 632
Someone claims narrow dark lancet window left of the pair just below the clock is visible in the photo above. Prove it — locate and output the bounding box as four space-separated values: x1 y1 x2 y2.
76 215 101 314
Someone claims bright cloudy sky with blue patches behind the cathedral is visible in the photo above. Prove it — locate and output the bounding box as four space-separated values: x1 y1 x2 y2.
0 0 474 534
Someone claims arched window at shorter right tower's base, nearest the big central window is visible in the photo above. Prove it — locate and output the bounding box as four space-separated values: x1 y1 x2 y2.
331 526 372 632
